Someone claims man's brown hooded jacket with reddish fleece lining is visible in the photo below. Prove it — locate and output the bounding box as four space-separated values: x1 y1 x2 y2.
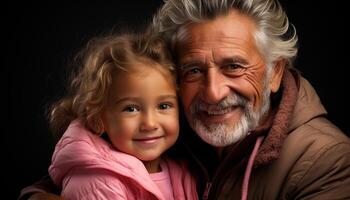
188 71 350 200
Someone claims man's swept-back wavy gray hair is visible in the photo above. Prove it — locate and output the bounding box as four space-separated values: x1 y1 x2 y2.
153 0 298 68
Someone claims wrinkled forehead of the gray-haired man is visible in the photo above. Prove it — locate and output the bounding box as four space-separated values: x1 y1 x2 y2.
175 11 256 60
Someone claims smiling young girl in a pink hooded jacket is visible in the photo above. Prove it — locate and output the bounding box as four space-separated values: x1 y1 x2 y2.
49 34 198 200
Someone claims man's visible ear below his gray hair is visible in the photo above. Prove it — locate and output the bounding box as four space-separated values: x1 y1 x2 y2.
269 59 286 93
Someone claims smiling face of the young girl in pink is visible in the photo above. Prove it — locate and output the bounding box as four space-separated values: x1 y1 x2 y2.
102 63 179 172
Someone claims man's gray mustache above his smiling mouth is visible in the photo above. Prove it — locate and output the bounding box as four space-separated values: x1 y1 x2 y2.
190 93 248 114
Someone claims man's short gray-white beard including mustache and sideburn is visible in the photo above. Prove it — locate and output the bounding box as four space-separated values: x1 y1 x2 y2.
187 76 270 147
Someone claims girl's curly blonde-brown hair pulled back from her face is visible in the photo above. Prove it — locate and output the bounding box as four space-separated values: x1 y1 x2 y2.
49 33 176 136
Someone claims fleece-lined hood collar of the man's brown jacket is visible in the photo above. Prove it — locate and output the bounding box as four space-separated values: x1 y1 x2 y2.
254 69 326 166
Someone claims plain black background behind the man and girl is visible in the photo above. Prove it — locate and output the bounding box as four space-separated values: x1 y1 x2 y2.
1 0 350 199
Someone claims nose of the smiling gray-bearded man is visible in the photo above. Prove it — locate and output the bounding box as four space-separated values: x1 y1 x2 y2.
202 67 230 104
